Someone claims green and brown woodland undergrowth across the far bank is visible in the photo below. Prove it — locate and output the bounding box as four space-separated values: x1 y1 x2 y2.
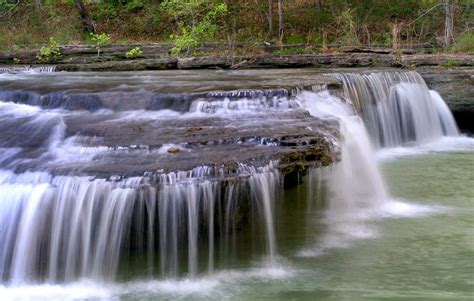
0 0 474 54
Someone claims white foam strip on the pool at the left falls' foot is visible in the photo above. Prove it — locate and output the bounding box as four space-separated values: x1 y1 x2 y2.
0 263 297 301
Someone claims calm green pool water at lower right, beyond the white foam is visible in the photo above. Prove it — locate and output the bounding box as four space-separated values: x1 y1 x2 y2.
219 152 474 300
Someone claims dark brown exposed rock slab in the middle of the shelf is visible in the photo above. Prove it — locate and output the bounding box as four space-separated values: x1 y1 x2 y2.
55 111 337 176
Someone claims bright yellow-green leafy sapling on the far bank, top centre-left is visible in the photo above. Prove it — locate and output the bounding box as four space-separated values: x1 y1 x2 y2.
161 0 227 55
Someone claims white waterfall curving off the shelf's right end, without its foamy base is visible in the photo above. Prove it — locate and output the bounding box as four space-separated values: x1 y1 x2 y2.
297 91 389 207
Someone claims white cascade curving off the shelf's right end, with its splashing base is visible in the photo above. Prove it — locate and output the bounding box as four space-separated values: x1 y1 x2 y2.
297 91 390 256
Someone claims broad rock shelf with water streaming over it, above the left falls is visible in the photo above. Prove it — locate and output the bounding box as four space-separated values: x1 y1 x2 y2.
0 71 340 178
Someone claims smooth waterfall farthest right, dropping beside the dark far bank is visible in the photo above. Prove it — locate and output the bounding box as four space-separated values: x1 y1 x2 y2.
334 71 458 147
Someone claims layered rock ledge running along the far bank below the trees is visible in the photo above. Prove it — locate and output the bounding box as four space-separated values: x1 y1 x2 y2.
0 44 474 71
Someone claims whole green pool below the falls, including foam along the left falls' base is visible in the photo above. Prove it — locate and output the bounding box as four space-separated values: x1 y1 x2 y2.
0 146 474 300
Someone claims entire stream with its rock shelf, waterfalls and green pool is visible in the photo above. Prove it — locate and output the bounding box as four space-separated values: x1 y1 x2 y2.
0 69 474 300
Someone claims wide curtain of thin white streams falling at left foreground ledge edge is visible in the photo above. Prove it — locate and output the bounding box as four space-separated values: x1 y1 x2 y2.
0 163 280 284
